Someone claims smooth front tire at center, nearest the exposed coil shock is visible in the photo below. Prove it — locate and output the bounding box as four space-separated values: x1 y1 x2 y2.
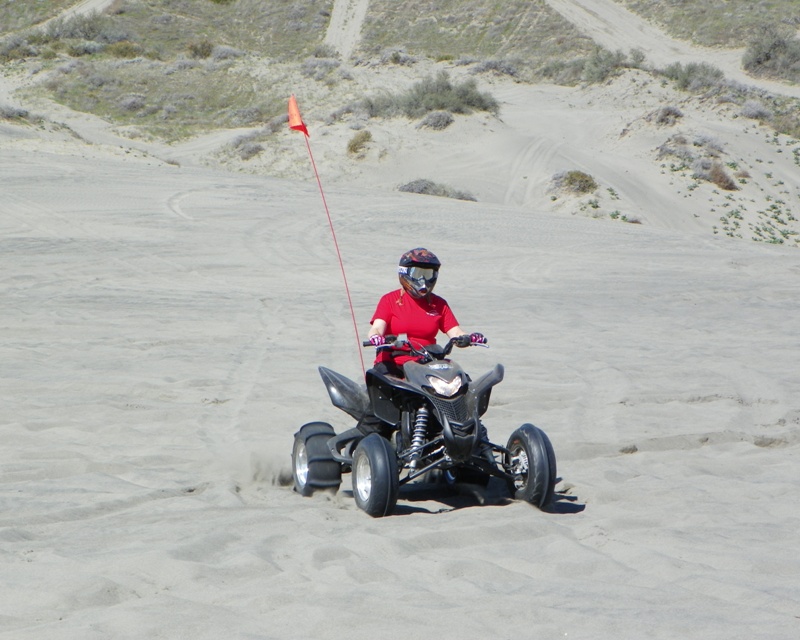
353 433 400 518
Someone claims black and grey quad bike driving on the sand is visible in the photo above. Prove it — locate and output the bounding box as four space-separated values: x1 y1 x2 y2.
292 335 556 517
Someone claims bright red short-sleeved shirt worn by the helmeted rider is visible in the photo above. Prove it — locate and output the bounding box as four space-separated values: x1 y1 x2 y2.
370 289 458 366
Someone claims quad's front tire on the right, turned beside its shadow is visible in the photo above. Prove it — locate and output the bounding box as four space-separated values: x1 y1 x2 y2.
506 424 556 509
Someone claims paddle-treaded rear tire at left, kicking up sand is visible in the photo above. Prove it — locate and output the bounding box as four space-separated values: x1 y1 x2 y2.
292 422 342 497
